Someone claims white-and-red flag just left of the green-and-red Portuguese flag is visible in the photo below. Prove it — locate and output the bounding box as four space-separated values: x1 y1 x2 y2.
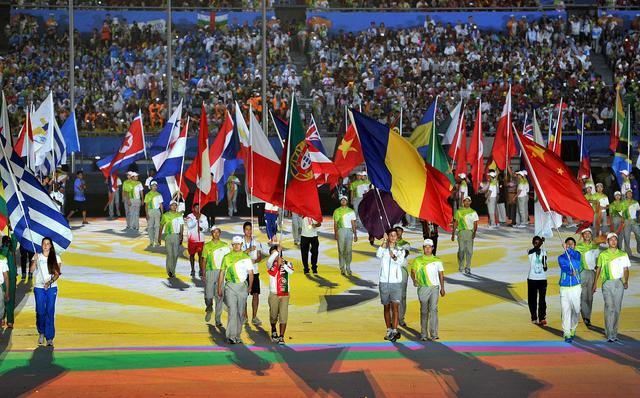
236 104 284 203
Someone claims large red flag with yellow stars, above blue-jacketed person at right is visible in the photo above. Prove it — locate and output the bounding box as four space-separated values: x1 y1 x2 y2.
515 132 593 221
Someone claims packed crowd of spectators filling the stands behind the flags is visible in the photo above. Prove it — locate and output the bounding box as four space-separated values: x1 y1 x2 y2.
0 8 638 134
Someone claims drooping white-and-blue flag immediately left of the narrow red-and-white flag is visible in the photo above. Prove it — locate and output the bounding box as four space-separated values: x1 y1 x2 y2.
154 118 189 206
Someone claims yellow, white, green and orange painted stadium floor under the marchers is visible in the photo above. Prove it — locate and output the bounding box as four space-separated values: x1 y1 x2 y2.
0 219 640 397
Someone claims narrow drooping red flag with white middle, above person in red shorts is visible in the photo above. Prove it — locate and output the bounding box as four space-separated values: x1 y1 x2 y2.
184 103 216 208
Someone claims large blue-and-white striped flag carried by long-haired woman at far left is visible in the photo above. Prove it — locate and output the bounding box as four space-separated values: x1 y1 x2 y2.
0 95 72 252
